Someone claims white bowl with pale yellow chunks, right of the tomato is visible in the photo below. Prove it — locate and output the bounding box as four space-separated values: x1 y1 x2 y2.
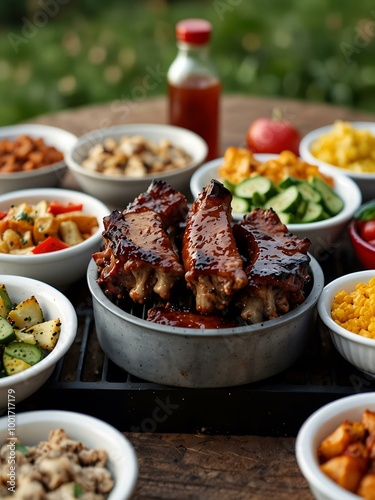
300 120 375 201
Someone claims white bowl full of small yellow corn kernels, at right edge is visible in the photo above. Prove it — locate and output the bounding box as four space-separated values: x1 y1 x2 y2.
317 269 375 378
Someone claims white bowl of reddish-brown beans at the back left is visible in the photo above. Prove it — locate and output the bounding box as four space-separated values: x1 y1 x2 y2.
0 123 77 194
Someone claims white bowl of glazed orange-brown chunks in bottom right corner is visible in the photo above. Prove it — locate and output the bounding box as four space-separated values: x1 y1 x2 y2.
296 391 375 500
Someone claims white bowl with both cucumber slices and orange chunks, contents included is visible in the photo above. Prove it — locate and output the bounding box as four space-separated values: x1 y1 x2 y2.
190 147 362 260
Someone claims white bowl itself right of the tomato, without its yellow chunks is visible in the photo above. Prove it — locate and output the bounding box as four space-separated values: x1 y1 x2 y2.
299 122 375 201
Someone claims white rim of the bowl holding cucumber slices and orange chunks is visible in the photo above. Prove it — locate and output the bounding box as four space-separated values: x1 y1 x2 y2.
190 154 362 227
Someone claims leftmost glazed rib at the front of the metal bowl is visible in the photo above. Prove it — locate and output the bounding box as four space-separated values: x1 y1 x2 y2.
93 207 184 304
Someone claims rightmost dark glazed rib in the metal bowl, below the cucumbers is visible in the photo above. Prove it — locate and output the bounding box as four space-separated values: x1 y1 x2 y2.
233 208 310 323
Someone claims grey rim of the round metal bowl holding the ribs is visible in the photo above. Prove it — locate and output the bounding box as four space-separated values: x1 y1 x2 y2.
86 254 324 338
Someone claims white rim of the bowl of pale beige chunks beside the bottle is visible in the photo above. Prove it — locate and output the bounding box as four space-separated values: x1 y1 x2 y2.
65 123 208 184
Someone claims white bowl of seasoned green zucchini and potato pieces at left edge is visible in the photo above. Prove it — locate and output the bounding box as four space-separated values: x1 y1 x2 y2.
0 274 77 413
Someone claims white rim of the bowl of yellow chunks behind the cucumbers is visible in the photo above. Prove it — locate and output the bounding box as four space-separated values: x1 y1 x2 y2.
299 121 375 181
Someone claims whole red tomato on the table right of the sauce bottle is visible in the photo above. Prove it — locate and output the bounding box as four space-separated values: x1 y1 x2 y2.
246 113 301 156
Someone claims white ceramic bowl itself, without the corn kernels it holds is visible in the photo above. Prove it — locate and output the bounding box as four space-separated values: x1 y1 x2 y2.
318 269 375 377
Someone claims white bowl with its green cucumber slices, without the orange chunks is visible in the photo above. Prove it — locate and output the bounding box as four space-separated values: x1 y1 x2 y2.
190 154 362 260
